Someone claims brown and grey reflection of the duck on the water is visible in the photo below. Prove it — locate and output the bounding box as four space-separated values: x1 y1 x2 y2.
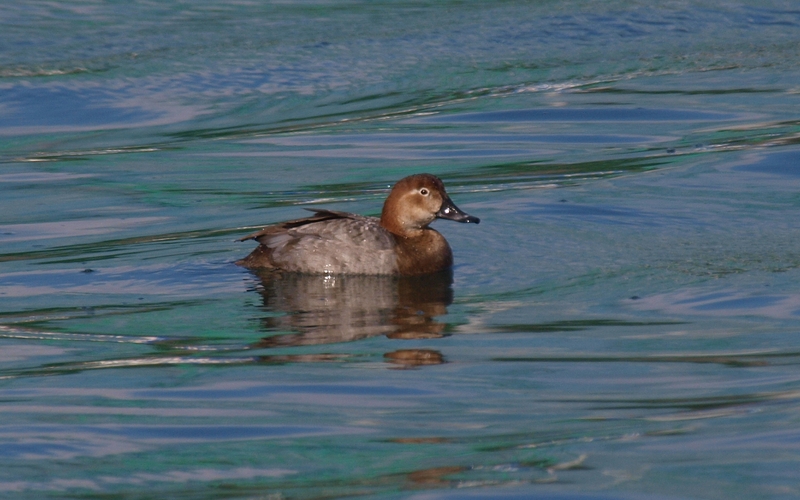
247 269 453 367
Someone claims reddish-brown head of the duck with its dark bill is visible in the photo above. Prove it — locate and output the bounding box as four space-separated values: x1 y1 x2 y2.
381 174 480 236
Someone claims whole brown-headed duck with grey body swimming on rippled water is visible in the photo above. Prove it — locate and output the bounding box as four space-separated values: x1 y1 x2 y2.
236 174 480 276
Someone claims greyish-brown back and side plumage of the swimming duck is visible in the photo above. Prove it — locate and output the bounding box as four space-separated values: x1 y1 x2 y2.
239 210 397 274
